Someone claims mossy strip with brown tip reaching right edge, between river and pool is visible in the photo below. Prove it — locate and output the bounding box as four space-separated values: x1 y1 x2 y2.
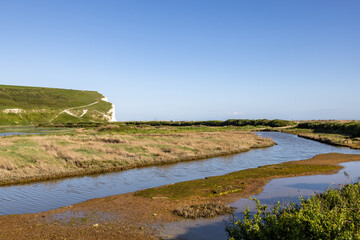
135 153 360 200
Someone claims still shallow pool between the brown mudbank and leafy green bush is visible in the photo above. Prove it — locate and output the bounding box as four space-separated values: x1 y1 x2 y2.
161 162 360 240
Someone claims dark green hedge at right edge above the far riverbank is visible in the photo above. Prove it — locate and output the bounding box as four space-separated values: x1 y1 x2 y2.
297 122 360 137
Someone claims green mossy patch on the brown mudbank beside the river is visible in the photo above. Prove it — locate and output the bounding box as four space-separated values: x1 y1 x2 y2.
136 163 341 200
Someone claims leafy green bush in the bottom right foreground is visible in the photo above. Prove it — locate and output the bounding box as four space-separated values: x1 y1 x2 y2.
225 183 360 240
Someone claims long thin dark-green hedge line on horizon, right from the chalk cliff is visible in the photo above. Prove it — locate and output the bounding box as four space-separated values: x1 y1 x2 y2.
39 119 296 128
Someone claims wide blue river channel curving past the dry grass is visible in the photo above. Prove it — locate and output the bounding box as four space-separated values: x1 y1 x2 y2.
0 132 360 215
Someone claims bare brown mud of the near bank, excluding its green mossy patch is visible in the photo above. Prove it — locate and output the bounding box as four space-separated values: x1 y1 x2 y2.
0 153 360 240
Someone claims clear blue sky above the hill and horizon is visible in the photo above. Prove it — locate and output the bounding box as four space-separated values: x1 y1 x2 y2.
0 0 360 121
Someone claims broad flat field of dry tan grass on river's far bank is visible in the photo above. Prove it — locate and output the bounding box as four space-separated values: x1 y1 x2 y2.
0 131 274 185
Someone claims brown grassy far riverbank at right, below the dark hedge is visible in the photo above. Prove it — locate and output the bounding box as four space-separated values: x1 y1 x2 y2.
282 128 360 149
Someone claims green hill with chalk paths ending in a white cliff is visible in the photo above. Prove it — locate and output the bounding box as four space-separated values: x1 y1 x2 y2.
0 85 115 125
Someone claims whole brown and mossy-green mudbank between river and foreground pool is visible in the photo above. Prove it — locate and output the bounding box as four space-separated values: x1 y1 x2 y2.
0 153 360 239
